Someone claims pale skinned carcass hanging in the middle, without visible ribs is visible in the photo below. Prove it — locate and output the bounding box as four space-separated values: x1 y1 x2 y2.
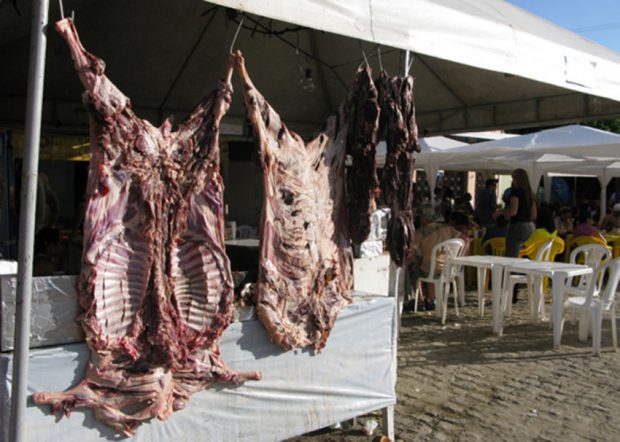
239 54 353 350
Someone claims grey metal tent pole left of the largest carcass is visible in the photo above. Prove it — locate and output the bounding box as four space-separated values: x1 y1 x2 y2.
9 0 49 442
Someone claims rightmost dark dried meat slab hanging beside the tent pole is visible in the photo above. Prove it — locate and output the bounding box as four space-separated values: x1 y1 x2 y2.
376 71 420 266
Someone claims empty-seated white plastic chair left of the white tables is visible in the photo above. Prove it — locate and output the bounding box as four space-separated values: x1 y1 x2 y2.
414 238 465 324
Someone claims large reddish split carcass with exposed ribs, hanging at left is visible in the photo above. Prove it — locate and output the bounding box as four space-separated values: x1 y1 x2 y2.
34 19 260 434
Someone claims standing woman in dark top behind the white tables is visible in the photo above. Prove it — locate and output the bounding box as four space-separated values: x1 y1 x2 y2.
498 169 536 258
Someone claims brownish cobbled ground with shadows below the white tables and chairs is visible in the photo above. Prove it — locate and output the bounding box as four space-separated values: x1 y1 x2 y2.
290 296 620 442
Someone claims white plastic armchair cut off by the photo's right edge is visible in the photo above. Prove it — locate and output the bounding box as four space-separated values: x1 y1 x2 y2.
562 258 620 354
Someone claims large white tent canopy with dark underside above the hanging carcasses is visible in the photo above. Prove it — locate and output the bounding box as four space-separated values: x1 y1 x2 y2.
0 0 620 136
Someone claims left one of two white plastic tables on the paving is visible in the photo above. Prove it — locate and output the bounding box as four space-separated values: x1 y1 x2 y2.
448 255 530 336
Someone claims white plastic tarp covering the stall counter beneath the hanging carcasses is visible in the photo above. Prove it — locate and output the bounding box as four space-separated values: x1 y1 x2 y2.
0 297 396 442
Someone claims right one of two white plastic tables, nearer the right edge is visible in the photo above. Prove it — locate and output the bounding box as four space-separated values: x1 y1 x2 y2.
506 261 592 347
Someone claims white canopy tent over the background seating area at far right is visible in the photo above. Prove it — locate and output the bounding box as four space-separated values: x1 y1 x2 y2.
429 125 620 218
